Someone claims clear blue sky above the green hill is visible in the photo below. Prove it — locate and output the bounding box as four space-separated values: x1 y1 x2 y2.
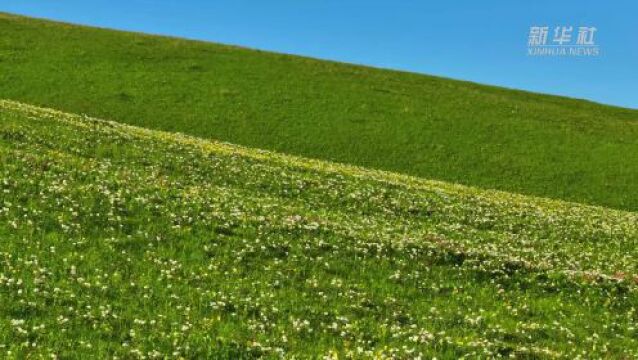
0 0 638 108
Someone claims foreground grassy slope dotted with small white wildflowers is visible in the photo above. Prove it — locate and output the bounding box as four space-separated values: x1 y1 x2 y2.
0 101 638 359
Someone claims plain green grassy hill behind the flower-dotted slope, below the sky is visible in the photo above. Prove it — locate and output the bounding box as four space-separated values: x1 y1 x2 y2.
0 14 638 210
